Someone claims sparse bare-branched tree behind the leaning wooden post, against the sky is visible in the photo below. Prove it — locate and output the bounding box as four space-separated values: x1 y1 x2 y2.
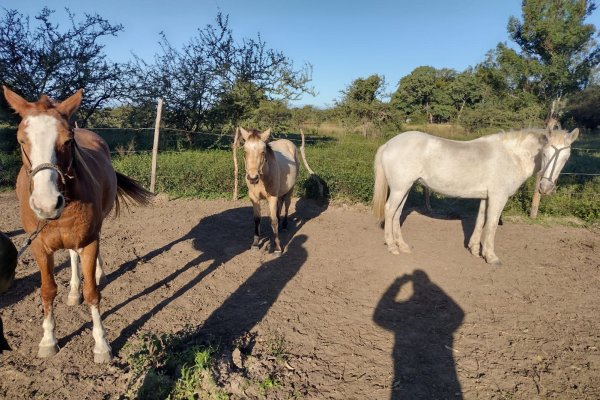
129 13 312 131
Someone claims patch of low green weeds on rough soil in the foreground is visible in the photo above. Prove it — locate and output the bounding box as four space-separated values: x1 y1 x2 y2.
124 328 305 400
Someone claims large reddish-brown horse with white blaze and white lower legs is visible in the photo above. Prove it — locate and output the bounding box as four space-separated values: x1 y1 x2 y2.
4 87 152 363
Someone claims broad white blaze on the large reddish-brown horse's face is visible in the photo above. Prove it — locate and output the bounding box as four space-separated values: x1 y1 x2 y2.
25 115 62 218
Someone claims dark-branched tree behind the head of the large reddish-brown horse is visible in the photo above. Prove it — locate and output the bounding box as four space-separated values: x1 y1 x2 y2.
0 8 123 126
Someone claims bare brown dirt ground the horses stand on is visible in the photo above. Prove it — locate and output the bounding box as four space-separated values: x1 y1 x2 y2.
0 193 600 399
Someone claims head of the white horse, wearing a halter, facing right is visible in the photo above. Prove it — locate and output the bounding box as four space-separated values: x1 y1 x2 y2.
540 129 579 194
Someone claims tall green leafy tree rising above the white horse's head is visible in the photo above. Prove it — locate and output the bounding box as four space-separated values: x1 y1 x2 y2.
497 0 600 108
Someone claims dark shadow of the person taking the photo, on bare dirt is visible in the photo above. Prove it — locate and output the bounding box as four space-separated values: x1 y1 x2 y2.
373 270 464 400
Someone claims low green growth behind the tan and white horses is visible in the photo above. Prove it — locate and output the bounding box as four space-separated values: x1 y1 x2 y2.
105 130 600 223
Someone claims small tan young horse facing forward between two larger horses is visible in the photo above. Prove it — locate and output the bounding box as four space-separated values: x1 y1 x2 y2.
240 128 298 255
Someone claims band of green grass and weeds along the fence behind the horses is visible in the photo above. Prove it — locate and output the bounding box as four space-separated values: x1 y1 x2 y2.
0 127 600 223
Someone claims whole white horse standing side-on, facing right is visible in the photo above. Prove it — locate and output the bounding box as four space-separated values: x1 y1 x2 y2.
373 129 579 264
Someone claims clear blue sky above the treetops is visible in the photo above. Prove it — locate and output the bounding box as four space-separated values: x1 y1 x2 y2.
2 0 600 107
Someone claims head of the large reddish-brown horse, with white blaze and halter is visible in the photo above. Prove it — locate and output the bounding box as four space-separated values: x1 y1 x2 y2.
4 87 83 220
